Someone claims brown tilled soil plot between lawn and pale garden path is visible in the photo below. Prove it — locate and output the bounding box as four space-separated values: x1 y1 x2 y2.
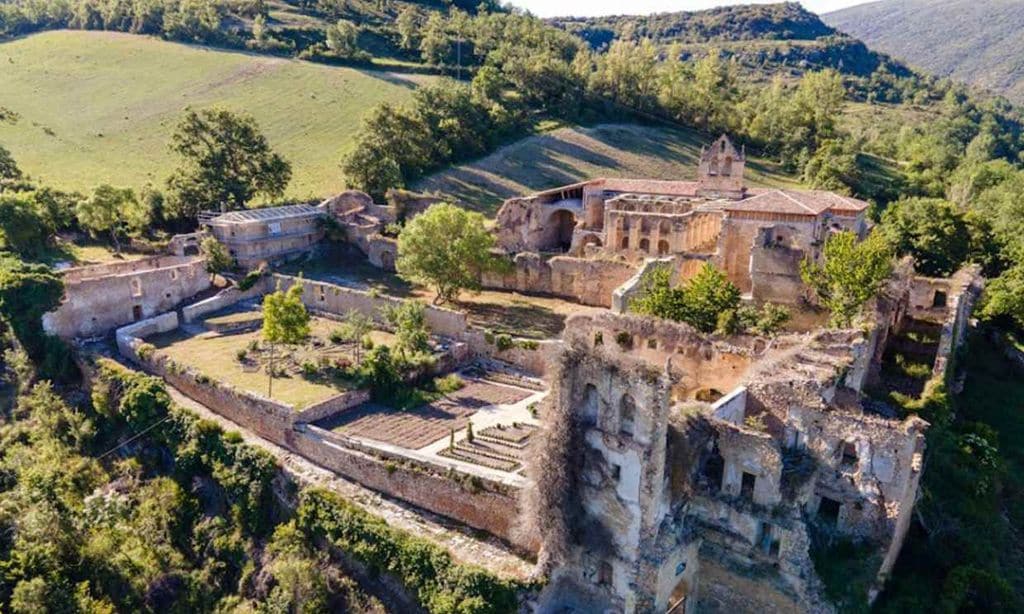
317 381 532 449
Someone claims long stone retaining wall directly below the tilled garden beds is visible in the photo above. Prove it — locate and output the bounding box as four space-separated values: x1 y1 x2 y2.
291 425 536 552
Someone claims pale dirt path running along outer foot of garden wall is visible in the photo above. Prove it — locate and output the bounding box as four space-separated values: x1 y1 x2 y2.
167 385 534 578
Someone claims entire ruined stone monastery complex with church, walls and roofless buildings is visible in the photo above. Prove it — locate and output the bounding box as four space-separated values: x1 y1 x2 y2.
44 136 982 613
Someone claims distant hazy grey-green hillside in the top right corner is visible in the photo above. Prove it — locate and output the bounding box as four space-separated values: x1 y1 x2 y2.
822 0 1024 102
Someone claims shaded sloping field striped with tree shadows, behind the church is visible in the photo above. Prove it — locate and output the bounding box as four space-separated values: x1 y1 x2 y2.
414 124 798 215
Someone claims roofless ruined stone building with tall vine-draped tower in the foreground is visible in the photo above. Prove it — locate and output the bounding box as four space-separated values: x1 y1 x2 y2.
527 302 962 612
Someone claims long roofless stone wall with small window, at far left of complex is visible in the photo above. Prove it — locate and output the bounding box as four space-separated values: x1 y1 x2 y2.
43 256 210 339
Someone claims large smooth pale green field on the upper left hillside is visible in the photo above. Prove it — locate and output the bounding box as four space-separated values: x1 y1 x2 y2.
0 31 430 198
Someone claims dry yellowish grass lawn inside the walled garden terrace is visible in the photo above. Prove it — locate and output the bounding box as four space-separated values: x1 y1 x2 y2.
146 317 394 409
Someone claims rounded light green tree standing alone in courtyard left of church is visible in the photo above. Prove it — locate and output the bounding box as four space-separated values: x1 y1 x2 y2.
395 203 499 303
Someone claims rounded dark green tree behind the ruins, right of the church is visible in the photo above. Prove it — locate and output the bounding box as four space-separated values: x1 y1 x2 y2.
881 198 971 277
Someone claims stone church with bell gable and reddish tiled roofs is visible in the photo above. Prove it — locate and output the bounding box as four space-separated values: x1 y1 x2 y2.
496 136 867 305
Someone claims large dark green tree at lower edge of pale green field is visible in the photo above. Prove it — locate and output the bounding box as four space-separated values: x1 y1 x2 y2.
167 109 292 218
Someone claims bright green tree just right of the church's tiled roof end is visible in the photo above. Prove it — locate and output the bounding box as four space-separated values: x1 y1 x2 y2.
800 231 893 327
